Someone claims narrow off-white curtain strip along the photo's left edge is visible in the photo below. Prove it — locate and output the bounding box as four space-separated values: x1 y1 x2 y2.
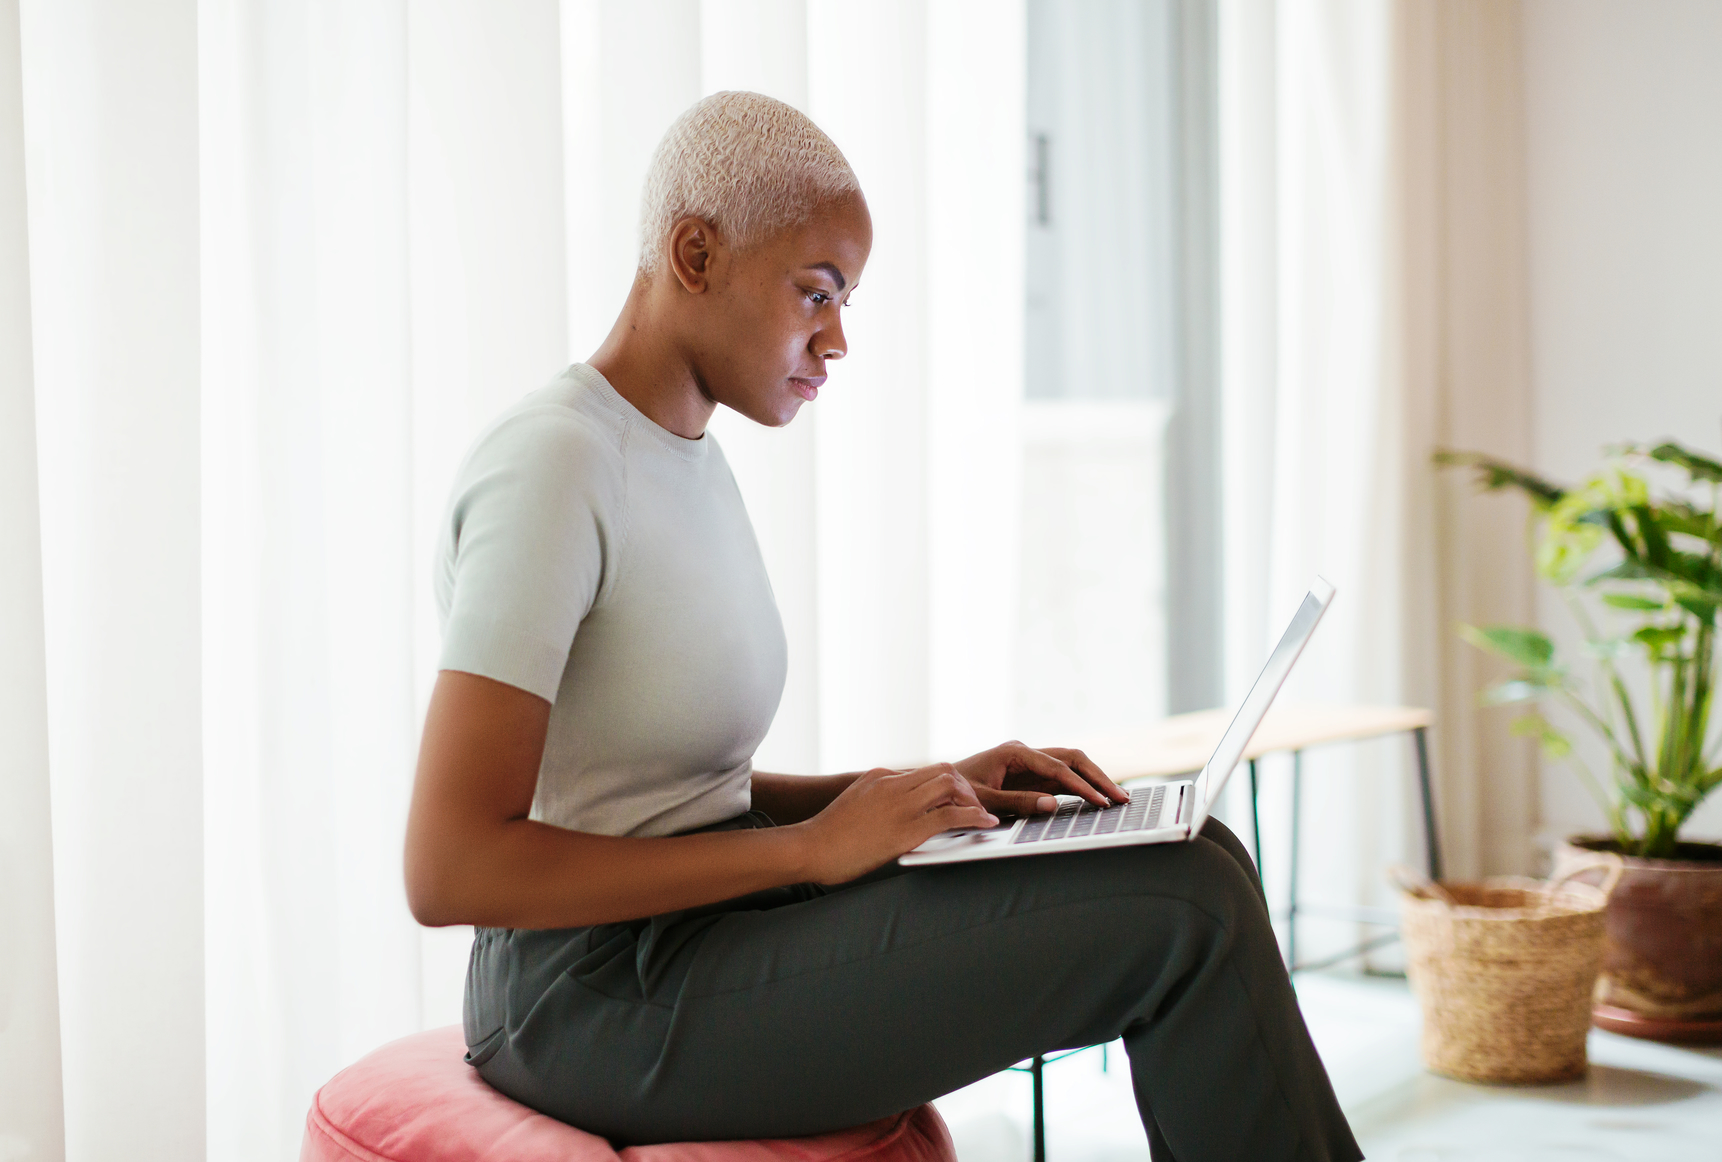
0 0 65 1162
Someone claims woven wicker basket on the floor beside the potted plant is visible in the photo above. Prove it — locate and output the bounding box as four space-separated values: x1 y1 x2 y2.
1395 857 1620 1085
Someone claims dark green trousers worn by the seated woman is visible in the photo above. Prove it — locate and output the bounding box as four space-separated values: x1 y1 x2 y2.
467 814 1362 1162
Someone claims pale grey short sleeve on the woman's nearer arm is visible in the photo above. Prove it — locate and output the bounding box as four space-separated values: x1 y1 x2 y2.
437 405 622 702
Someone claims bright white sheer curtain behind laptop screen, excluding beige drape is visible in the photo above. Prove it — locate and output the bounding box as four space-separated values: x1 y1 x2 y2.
1221 0 1417 959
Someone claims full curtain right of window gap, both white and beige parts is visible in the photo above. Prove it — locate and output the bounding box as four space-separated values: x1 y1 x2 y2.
1219 0 1536 959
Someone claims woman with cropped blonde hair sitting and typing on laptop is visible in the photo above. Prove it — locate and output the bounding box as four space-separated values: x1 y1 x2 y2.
406 93 1360 1160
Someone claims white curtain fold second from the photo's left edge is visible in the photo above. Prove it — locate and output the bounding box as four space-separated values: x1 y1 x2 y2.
22 0 205 1162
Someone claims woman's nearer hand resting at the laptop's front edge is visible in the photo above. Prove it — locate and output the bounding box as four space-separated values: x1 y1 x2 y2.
796 763 999 883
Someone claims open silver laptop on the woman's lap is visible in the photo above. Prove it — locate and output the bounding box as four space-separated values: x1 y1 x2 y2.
897 577 1333 868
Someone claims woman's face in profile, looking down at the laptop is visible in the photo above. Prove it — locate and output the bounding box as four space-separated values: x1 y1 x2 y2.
692 195 873 427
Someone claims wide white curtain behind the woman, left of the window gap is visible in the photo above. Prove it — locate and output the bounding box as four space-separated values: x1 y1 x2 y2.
0 0 1023 1162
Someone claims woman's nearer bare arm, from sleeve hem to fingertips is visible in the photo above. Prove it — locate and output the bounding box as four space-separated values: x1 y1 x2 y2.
406 670 997 928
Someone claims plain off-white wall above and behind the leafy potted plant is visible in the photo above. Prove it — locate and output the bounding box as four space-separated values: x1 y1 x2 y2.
1524 0 1722 846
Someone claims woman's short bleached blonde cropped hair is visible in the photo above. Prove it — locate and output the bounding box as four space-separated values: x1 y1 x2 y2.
641 91 861 274
